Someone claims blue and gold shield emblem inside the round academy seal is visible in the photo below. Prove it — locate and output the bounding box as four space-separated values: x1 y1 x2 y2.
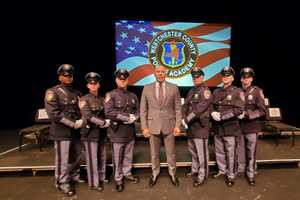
161 41 185 68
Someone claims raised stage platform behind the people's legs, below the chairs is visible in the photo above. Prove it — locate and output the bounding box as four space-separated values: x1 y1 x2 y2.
0 136 300 171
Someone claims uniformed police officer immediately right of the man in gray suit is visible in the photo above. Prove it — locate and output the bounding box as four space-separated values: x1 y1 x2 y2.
182 67 212 187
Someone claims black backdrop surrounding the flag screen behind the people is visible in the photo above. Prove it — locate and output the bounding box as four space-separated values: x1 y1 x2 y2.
0 1 300 127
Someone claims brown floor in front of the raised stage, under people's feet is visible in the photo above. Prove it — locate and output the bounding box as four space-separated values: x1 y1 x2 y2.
0 168 300 200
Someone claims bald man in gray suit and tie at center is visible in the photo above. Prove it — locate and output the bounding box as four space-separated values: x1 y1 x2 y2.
140 66 181 187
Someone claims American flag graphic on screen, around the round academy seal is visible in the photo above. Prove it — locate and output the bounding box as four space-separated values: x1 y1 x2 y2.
115 20 231 87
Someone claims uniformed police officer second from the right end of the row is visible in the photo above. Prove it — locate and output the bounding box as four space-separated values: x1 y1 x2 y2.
211 67 245 187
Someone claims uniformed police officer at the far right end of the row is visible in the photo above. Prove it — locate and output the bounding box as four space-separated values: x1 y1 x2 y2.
238 67 266 186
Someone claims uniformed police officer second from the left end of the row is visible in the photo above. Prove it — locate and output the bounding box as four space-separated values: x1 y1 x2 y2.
79 72 110 191
